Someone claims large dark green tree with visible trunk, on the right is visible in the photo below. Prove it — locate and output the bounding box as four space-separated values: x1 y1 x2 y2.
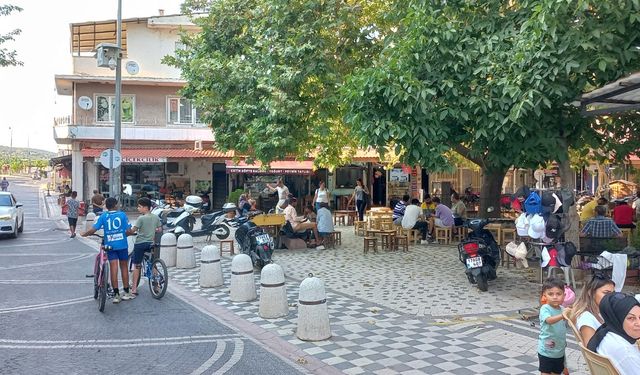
344 0 640 216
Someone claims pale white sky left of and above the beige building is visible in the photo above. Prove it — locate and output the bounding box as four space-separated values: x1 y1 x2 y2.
0 0 182 152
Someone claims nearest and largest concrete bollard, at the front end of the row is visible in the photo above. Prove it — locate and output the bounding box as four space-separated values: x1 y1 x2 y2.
296 274 331 341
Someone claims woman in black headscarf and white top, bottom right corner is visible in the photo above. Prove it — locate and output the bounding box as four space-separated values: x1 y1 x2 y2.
587 293 640 375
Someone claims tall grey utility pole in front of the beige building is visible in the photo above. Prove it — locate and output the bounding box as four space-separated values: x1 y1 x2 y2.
109 0 122 199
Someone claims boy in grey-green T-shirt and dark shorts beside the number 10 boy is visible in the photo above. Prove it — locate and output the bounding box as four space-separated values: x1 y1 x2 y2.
129 198 162 296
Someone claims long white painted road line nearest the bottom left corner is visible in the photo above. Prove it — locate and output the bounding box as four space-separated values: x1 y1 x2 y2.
0 335 244 352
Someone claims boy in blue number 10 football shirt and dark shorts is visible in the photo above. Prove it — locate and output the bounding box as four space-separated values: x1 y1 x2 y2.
81 197 135 303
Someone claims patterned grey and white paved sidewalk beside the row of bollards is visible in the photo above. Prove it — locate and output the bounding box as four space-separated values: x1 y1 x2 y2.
42 195 589 374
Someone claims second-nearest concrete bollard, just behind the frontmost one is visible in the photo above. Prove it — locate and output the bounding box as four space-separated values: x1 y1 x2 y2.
258 263 289 319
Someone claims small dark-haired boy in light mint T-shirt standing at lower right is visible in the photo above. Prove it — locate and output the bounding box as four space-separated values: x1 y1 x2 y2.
538 278 567 375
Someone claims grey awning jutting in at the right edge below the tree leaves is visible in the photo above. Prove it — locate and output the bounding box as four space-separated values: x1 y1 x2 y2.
580 72 640 116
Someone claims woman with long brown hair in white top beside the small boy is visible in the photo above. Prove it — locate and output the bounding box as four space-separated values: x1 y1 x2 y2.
571 273 616 345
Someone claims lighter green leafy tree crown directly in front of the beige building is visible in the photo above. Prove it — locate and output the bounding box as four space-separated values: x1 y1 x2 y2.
165 0 385 166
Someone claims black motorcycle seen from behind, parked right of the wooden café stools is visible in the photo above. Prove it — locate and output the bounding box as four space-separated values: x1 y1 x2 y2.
458 219 500 292
